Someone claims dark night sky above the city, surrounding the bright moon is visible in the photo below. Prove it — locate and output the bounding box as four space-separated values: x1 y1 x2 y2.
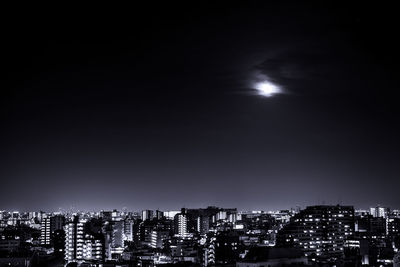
0 1 400 210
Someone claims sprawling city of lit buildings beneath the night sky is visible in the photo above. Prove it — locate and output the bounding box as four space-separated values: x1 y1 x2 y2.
0 205 400 267
